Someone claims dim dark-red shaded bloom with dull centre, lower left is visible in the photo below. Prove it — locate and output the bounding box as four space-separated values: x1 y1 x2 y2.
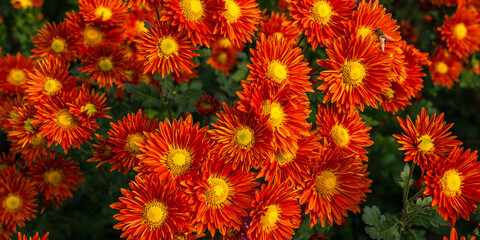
28 153 85 208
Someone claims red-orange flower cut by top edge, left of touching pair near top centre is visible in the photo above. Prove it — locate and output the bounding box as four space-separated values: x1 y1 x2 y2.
160 0 217 48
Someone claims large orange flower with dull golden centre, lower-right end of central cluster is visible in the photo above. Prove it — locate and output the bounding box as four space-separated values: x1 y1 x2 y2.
299 149 371 228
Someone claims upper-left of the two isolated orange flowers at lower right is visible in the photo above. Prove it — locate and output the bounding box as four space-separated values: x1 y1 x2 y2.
393 108 462 170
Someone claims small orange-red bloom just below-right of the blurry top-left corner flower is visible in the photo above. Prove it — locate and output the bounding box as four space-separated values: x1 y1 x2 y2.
32 22 79 62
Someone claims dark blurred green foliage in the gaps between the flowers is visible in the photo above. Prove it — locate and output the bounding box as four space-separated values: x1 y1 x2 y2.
0 0 480 240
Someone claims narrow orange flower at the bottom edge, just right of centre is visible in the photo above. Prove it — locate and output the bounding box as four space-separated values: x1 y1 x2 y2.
248 182 302 240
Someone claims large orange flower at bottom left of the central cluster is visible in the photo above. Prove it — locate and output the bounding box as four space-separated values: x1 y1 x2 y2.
110 174 191 240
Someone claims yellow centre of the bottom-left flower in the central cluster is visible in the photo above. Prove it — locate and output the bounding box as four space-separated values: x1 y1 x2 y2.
141 200 168 230
